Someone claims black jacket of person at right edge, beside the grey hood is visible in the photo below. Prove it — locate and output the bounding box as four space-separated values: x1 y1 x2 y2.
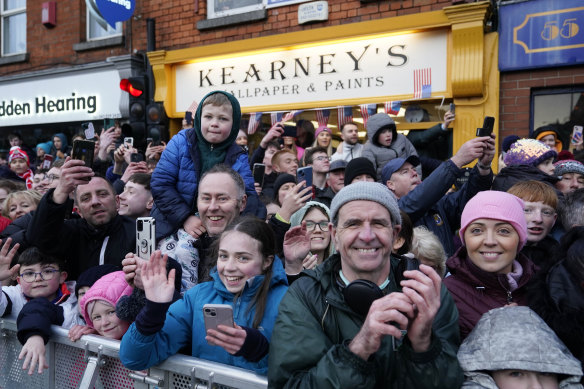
528 227 584 364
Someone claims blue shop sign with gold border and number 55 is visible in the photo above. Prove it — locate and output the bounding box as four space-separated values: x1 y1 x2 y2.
499 0 584 71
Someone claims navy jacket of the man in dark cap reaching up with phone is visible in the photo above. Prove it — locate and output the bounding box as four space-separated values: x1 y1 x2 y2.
398 160 493 256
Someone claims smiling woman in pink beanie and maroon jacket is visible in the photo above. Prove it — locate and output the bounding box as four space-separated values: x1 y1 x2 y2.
444 191 536 339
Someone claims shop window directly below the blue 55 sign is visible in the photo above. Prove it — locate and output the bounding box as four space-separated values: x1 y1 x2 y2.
530 85 584 149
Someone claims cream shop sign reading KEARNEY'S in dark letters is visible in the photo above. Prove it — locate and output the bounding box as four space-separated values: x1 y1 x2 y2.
175 30 448 112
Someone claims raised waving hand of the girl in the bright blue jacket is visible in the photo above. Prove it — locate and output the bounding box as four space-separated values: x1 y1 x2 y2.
141 250 176 303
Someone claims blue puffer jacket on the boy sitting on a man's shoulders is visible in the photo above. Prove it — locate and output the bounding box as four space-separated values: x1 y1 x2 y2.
151 128 261 238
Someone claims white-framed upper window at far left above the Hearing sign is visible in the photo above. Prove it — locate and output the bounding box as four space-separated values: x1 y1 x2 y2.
0 0 26 57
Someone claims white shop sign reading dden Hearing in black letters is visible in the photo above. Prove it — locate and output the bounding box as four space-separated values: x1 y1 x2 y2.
0 70 122 127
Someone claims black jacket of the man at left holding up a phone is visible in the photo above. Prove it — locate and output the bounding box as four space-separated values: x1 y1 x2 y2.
26 189 136 280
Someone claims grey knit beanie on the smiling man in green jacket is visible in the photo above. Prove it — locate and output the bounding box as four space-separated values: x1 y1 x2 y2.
331 181 401 224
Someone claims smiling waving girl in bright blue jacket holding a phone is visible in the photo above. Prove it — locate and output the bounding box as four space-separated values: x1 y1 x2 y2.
120 218 287 374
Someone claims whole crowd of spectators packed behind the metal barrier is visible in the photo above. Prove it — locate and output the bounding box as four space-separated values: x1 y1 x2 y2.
0 91 584 389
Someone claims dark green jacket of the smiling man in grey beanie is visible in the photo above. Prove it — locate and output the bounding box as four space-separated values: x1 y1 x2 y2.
268 254 463 389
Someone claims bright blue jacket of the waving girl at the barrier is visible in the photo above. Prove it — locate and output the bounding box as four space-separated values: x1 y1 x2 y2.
120 258 288 375
